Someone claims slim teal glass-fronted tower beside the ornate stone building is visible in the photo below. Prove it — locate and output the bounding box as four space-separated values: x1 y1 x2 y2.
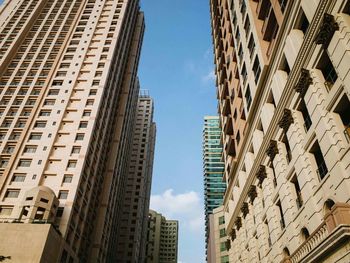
203 116 226 262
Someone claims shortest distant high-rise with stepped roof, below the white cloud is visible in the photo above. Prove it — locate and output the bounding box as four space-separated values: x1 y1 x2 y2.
145 210 179 263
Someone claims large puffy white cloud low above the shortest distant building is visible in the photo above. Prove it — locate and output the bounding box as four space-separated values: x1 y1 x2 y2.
151 189 204 232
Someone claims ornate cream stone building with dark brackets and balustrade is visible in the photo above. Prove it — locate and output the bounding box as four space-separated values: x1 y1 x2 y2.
210 0 350 263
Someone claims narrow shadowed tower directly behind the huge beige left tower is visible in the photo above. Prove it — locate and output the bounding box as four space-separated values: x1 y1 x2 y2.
116 91 156 263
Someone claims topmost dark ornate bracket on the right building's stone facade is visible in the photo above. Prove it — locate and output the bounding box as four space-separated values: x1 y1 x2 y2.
315 13 339 49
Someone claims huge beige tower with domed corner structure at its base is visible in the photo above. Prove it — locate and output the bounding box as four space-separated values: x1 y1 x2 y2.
0 0 144 262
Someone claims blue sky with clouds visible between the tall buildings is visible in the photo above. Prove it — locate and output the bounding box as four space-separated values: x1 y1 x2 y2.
139 0 217 263
